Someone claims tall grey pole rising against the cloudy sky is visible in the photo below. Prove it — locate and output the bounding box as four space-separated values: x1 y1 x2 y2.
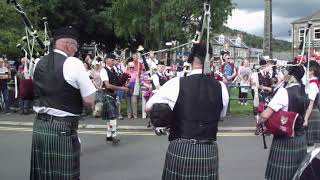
263 0 272 59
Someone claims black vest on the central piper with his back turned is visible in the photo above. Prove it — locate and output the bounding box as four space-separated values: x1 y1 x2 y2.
169 74 223 141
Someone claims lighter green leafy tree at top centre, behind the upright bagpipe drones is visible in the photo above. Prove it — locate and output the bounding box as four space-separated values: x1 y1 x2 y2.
110 0 234 49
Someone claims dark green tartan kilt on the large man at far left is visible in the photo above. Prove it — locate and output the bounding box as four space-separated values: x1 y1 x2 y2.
30 116 80 180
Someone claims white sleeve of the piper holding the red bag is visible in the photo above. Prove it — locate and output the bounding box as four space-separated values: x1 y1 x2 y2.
268 88 289 112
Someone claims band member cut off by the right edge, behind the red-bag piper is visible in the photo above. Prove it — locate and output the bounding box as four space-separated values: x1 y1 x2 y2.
303 61 320 150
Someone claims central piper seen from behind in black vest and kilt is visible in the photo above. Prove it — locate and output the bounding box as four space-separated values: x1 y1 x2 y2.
145 45 229 180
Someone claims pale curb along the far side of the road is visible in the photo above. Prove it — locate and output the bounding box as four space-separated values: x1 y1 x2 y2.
0 121 256 132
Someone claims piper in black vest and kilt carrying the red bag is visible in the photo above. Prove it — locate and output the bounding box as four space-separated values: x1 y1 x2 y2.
258 66 307 180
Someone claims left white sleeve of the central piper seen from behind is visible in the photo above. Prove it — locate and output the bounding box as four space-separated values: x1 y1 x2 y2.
146 77 180 110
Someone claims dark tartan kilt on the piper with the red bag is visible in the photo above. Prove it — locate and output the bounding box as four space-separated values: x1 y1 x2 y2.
265 135 307 180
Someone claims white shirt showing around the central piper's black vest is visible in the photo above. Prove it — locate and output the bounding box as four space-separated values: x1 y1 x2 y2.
146 69 229 117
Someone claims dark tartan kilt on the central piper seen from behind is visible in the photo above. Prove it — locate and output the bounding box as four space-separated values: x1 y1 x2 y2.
162 140 219 180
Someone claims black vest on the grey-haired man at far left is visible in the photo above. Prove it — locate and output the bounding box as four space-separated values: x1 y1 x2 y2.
33 53 83 114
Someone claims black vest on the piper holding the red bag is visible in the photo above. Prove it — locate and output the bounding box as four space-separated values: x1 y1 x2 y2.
286 86 307 136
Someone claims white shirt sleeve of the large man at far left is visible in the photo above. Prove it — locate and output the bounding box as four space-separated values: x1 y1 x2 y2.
63 57 96 97
